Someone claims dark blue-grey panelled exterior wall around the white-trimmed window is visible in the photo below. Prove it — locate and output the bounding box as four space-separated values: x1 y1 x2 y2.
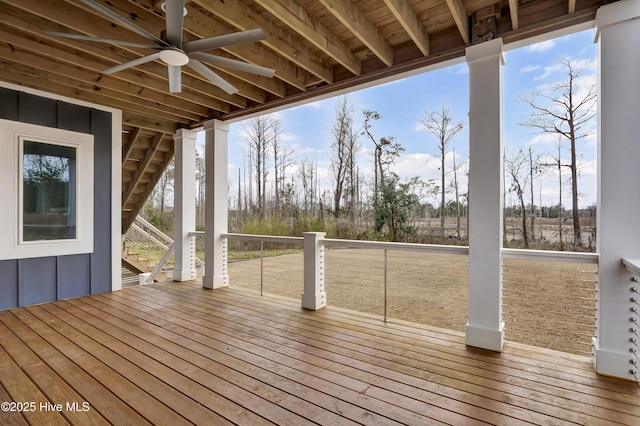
0 87 113 309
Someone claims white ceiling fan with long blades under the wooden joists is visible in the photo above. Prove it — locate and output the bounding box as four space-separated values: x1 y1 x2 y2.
47 0 275 95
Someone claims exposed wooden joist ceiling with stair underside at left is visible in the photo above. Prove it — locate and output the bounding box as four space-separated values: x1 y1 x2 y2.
0 0 617 231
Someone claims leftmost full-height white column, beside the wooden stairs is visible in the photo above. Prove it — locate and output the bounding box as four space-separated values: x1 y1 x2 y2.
173 129 196 281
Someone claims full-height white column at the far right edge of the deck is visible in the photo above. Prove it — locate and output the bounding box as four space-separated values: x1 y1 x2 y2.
594 0 640 379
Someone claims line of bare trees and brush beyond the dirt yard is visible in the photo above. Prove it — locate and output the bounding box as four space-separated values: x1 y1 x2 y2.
145 58 596 250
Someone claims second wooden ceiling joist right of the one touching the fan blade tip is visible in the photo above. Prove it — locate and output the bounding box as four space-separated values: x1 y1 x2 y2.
319 0 393 67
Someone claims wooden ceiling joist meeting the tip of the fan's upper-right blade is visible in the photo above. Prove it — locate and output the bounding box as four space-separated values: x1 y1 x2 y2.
191 0 333 85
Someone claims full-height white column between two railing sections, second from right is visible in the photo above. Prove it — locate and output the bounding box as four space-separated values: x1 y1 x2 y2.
466 38 504 351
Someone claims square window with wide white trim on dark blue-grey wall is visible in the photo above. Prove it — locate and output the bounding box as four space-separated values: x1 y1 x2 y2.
0 120 94 259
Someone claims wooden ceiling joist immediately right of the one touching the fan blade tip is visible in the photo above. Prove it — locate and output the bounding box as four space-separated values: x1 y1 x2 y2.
256 0 362 75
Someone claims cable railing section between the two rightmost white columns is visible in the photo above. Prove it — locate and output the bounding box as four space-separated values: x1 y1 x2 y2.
502 249 598 355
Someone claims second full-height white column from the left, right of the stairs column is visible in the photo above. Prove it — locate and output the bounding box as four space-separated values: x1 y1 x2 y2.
202 120 229 289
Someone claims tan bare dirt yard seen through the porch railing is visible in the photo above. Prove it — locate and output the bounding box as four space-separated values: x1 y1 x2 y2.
229 249 596 355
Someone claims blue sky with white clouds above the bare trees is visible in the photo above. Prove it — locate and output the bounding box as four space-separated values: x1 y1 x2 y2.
218 30 596 207
